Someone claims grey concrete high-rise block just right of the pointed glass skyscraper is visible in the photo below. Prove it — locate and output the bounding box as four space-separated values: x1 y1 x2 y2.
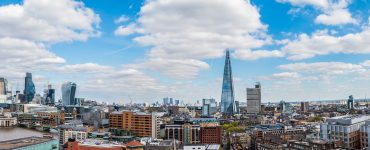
247 82 261 114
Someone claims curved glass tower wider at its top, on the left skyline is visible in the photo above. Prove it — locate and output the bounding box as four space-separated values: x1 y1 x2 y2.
62 82 77 106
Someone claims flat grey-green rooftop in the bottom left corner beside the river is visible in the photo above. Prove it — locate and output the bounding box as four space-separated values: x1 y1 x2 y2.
0 137 54 150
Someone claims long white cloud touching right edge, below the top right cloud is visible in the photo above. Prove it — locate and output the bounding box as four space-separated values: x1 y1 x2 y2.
282 28 370 60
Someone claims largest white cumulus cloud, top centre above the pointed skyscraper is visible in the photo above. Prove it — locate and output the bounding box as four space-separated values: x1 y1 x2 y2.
115 0 270 78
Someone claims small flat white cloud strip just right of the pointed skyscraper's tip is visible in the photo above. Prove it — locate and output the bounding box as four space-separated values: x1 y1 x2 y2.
234 50 284 60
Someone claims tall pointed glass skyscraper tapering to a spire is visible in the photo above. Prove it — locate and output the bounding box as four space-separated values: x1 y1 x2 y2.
221 50 235 116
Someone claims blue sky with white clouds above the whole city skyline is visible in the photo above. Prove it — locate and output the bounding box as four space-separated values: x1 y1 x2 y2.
0 0 370 103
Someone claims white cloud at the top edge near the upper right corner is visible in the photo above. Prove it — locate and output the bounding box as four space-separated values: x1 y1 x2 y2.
276 0 357 25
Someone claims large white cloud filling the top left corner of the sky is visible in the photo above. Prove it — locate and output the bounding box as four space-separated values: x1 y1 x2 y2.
0 0 100 42
